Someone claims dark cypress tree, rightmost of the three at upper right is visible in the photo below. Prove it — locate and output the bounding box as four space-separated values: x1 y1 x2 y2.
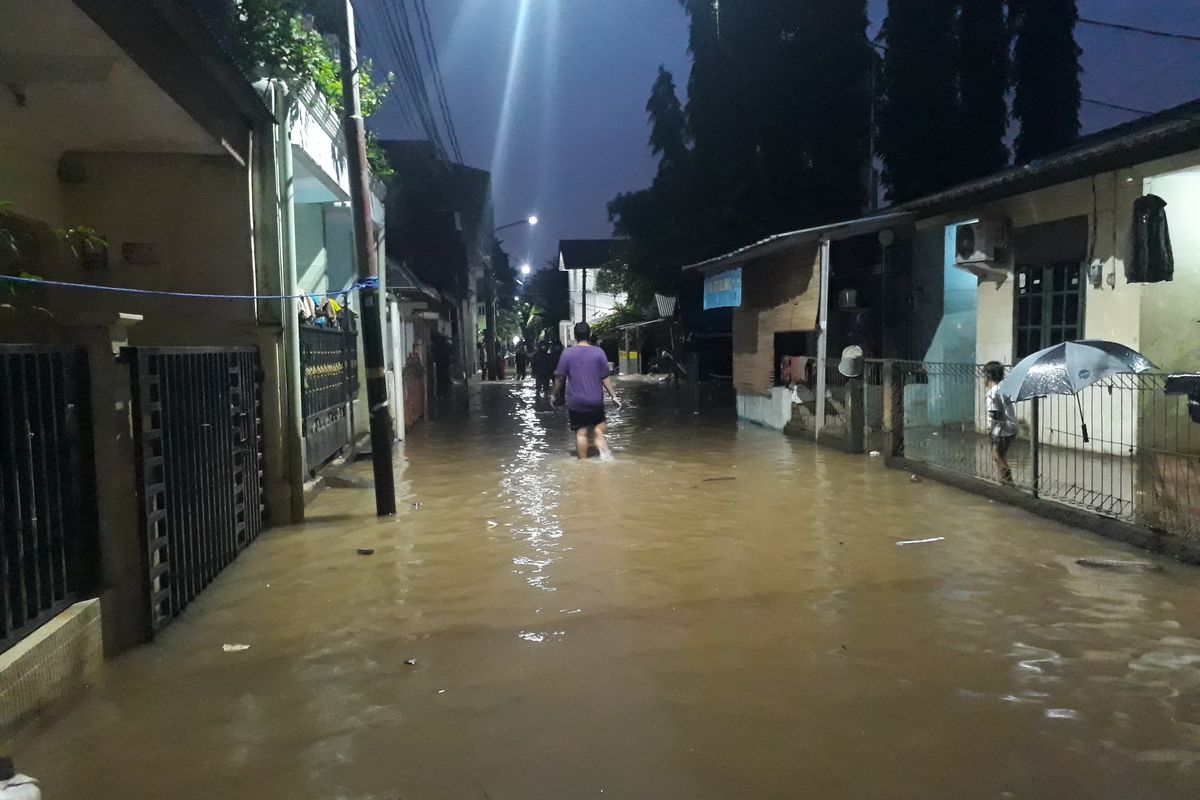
1010 0 1082 164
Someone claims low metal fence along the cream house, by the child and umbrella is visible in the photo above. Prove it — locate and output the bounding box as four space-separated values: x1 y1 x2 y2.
892 362 1200 537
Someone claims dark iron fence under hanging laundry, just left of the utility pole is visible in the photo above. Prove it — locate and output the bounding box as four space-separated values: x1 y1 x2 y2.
300 324 359 470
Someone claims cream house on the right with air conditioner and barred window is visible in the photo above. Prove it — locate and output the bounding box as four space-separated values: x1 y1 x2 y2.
905 102 1200 544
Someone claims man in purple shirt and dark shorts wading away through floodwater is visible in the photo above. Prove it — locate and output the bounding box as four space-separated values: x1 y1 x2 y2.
551 323 620 461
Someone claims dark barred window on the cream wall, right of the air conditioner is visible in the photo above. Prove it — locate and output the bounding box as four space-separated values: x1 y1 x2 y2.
1014 259 1084 360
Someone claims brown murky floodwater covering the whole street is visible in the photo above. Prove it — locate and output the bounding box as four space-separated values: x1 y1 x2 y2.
11 385 1200 800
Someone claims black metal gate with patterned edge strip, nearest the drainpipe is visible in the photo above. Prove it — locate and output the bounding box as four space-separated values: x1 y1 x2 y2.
126 348 265 632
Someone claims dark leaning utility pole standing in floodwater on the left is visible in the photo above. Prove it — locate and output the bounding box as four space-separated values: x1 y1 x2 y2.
338 0 396 517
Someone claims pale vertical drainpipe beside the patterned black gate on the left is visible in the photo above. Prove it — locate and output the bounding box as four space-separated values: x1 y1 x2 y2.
271 80 305 523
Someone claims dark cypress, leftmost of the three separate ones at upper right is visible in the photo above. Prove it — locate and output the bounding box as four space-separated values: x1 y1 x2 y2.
878 0 960 201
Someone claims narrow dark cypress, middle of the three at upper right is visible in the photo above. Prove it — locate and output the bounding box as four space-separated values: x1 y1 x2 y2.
953 0 1012 180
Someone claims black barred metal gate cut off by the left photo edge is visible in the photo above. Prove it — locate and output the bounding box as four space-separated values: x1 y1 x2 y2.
0 344 97 651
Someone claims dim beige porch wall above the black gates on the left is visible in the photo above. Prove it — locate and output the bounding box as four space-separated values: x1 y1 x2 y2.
38 152 256 345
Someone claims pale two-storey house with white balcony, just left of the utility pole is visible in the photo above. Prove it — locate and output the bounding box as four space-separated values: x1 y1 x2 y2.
256 78 386 506
